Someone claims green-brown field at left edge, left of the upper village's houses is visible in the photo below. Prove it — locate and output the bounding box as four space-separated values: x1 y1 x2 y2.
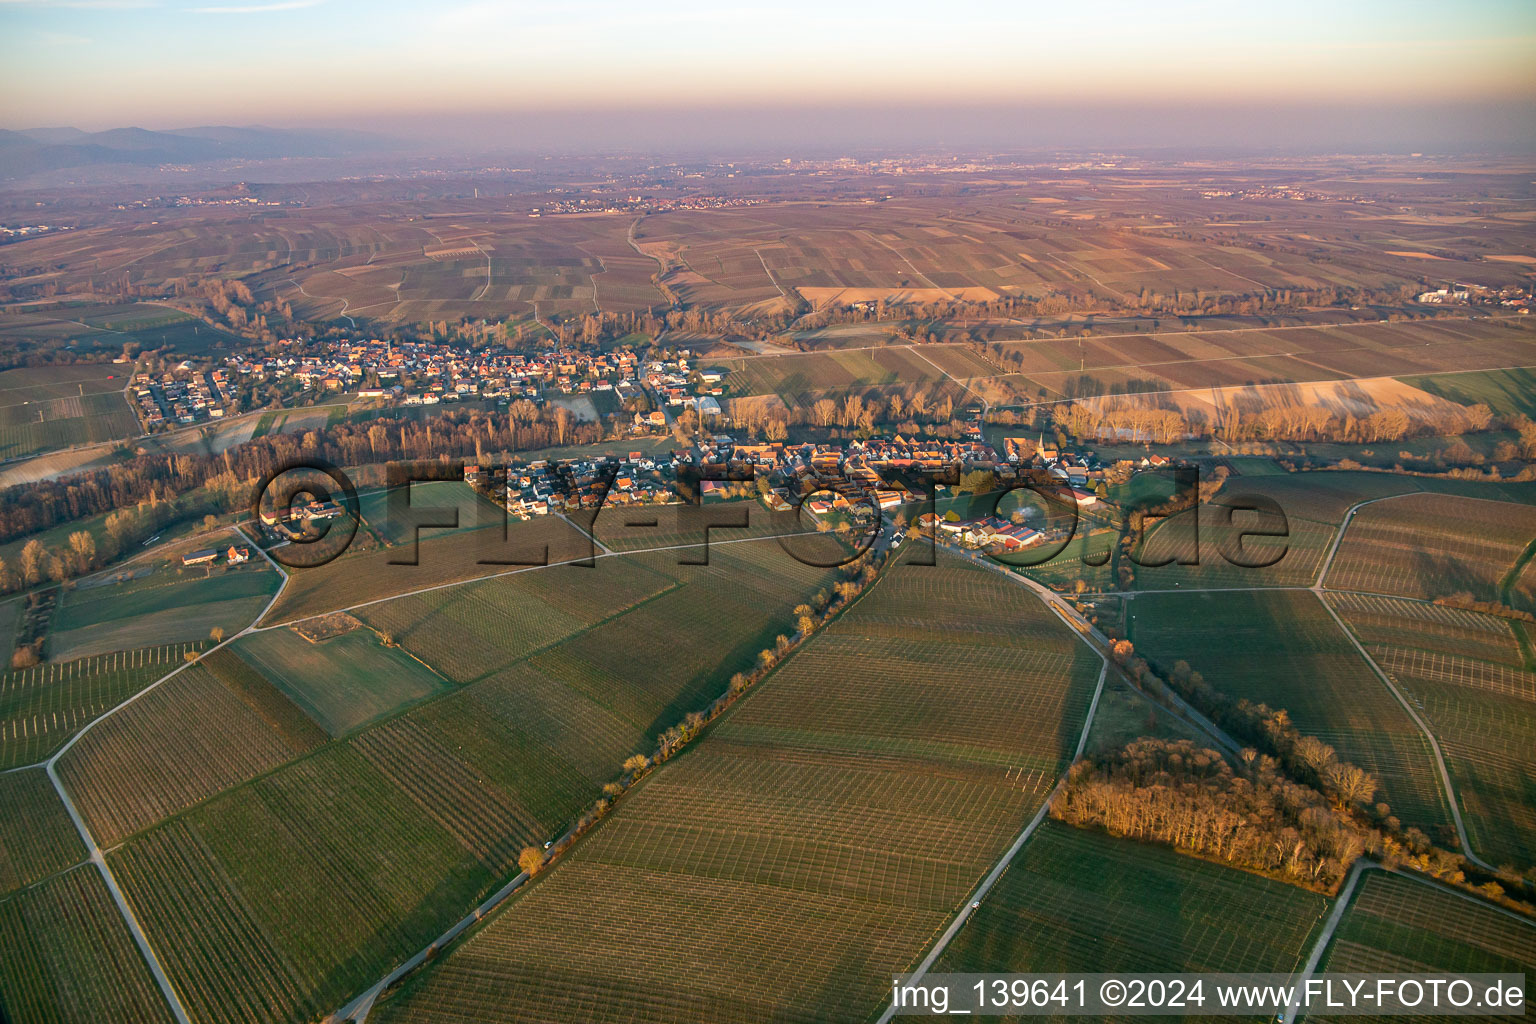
0 365 140 459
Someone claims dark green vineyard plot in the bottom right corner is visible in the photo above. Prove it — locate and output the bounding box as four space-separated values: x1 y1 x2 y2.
1309 870 1536 1021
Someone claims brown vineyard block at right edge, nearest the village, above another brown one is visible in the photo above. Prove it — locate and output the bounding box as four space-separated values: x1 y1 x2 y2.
1324 494 1536 611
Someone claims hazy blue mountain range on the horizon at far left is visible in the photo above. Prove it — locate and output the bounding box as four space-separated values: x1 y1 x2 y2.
0 124 390 178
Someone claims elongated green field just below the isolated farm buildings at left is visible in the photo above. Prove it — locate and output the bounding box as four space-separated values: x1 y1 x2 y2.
48 562 281 659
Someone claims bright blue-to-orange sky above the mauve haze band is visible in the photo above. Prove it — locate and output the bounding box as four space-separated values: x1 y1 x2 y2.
0 0 1536 141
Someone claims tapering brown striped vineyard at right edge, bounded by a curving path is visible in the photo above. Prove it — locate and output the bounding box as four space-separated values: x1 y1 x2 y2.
1327 594 1536 867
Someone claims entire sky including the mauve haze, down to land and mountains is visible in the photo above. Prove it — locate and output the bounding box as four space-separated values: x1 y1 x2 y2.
0 0 1536 149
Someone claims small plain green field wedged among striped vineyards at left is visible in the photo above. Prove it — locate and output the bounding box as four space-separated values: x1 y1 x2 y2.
233 628 447 735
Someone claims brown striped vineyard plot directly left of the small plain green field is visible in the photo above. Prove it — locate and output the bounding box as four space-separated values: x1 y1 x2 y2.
58 659 327 846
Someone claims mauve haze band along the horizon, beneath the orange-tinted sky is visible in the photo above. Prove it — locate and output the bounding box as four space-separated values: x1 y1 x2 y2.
9 103 1536 158
